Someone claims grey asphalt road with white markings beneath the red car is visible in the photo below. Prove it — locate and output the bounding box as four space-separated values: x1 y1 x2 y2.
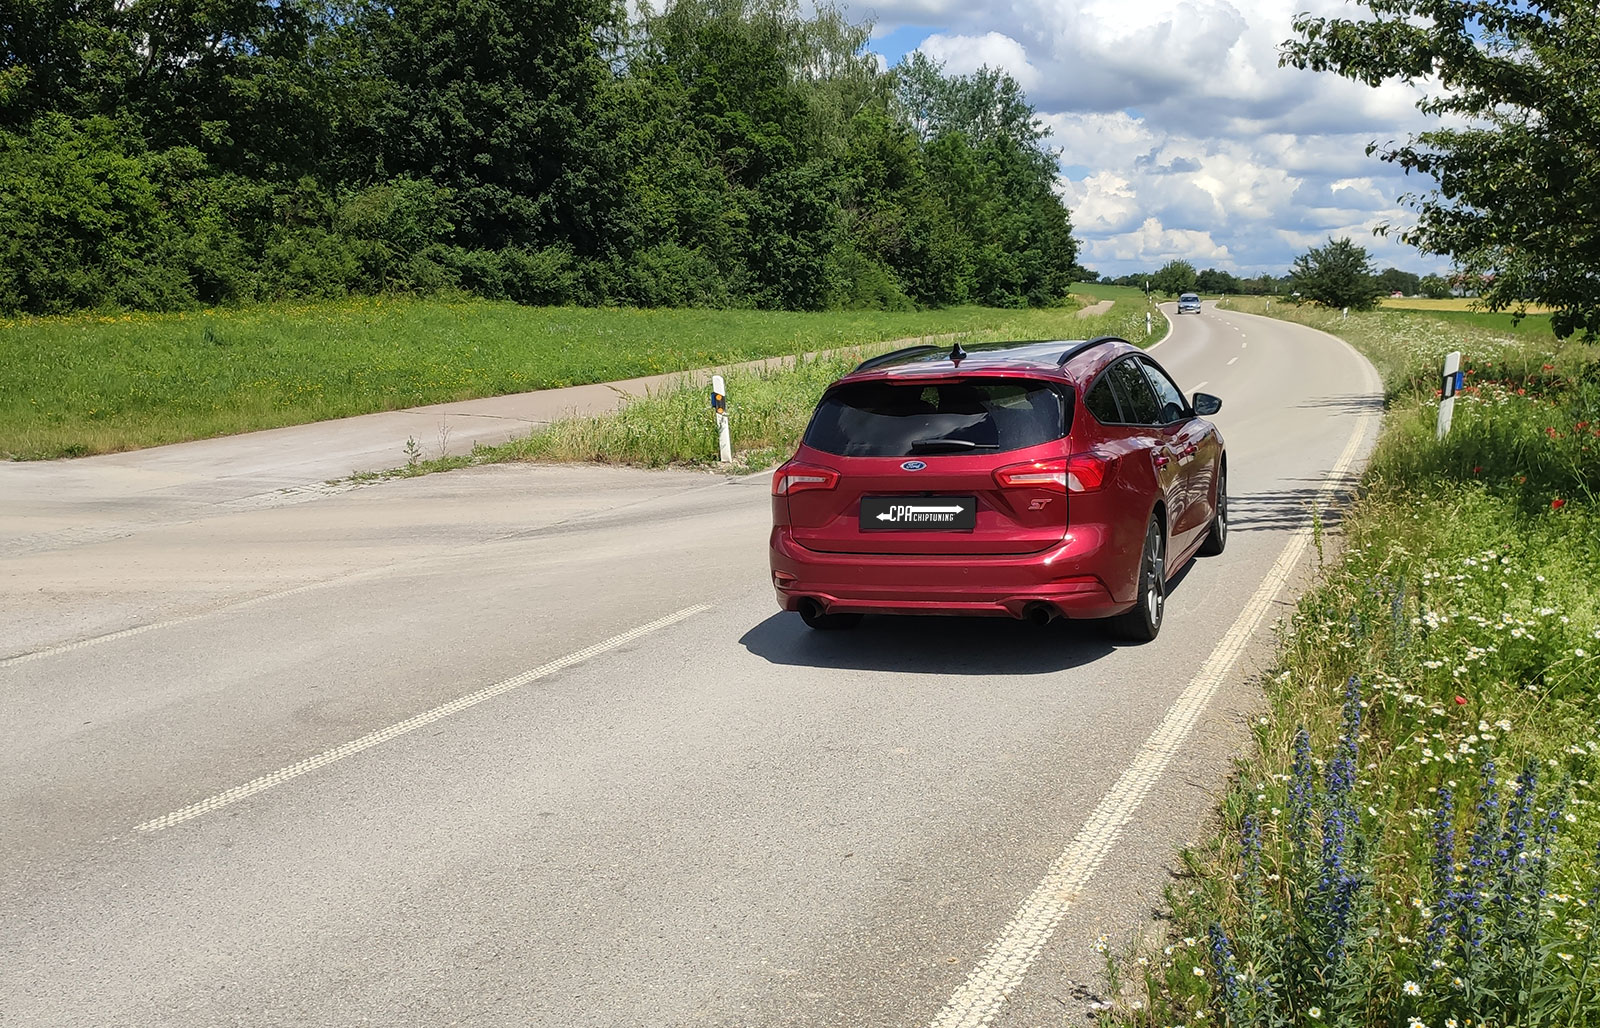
0 306 1381 1028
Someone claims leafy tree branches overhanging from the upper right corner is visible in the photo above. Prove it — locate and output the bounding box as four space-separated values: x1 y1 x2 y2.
1282 0 1600 339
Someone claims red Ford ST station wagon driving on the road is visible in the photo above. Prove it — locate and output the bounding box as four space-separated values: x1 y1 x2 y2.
771 336 1227 640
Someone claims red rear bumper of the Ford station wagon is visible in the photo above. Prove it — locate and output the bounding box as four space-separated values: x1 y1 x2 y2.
771 525 1131 618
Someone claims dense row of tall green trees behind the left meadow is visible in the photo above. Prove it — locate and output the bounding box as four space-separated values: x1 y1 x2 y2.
0 0 1080 314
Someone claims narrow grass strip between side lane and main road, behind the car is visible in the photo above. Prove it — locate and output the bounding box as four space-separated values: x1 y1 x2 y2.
464 293 1166 471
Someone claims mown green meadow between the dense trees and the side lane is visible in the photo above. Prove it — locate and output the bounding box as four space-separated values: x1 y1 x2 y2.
0 299 1177 458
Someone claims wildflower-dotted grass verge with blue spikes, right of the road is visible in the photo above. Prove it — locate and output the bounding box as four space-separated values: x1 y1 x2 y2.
1107 304 1600 1028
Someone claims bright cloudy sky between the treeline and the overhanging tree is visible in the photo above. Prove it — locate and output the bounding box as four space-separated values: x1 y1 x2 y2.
846 0 1448 275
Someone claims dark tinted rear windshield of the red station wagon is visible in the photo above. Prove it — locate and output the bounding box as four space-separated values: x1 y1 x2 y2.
805 378 1072 456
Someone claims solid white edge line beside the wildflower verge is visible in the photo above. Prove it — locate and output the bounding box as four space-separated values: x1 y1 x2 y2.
930 385 1370 1028
